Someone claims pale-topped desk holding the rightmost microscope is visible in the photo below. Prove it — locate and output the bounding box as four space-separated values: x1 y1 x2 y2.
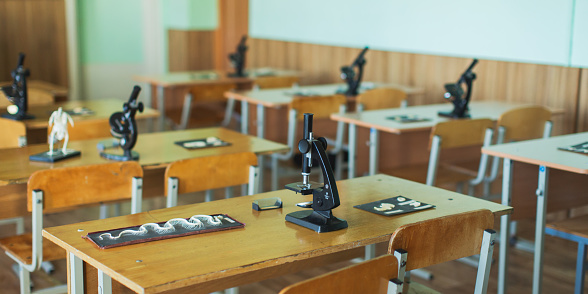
331 101 561 178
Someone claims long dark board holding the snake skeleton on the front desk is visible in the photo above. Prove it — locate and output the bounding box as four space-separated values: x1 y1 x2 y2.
83 214 245 249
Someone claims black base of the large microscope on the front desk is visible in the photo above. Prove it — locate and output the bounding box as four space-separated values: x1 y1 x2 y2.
286 210 347 233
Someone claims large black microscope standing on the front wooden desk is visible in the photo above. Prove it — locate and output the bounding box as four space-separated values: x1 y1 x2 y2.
286 113 347 233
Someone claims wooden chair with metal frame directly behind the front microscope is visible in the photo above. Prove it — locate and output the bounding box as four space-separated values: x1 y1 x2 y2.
272 95 347 191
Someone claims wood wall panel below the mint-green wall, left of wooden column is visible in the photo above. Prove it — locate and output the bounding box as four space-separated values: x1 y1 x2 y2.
168 30 216 72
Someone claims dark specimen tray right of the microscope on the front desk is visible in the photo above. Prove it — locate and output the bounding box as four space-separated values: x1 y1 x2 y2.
353 196 435 216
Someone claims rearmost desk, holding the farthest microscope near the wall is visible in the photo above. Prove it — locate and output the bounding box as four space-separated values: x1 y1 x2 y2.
133 68 298 128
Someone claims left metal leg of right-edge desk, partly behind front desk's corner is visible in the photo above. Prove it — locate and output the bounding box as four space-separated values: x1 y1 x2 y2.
498 158 512 294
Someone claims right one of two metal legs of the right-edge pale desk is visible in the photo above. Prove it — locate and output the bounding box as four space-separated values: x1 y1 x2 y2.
533 165 549 294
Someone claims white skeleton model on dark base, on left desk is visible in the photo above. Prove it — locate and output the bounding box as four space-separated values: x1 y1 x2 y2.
29 107 81 162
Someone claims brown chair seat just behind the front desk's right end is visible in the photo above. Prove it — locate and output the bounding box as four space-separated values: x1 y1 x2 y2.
382 164 475 185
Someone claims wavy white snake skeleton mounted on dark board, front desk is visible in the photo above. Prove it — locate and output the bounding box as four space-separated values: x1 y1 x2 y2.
98 215 226 240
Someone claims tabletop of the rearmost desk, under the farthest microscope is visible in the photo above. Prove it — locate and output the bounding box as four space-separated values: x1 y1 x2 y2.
133 68 298 87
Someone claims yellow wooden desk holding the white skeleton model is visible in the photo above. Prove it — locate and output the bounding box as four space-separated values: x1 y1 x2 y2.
0 128 288 215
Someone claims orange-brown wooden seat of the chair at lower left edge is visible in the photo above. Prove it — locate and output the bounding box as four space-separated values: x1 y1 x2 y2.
0 234 66 264
